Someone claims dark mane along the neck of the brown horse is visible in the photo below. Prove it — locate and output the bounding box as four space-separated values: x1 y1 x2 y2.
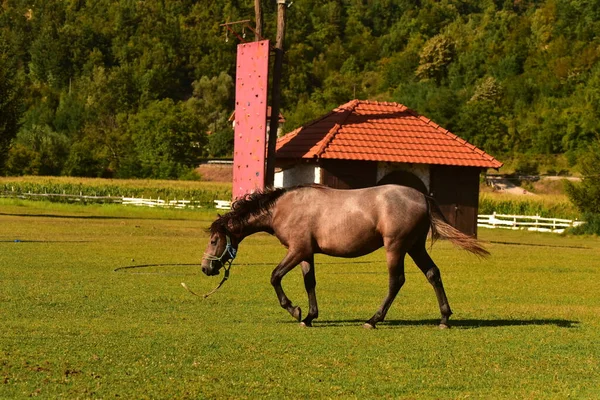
209 184 326 234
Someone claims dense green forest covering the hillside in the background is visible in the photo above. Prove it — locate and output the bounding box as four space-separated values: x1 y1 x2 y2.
0 0 600 179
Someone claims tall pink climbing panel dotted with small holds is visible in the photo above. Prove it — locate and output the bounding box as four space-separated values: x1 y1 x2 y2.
233 40 269 199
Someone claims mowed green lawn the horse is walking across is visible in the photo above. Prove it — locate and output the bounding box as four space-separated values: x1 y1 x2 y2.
0 200 600 399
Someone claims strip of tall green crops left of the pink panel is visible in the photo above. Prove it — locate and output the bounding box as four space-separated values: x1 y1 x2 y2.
0 177 231 207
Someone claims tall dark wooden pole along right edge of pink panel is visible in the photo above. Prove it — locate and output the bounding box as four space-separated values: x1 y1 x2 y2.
265 0 287 187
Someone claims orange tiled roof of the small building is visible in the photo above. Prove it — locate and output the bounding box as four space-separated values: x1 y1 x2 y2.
277 100 502 168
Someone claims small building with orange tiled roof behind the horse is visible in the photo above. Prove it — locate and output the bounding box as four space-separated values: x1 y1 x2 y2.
275 100 502 236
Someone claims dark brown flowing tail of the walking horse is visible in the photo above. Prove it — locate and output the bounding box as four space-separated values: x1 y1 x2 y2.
425 195 490 257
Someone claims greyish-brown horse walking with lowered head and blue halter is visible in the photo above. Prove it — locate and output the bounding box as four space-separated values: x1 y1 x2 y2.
202 184 489 328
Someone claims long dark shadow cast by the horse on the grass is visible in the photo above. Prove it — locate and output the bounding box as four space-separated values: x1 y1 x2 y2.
302 318 579 329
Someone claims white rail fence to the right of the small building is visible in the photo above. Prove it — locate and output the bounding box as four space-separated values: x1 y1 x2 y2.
477 213 584 233
